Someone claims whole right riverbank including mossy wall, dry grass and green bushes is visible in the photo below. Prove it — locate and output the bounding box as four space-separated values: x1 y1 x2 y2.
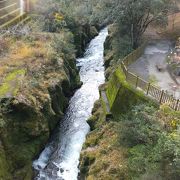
79 27 180 180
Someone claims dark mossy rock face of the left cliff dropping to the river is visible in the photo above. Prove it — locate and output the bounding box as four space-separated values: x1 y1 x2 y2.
0 58 80 180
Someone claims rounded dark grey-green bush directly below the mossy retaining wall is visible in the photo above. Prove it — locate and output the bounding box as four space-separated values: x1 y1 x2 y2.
121 104 160 146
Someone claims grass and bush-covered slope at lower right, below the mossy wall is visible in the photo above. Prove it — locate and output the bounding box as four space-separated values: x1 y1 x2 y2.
80 97 180 180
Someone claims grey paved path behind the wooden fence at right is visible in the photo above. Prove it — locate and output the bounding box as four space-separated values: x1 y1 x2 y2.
129 40 180 98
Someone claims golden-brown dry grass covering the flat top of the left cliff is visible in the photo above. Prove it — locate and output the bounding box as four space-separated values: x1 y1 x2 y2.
0 32 73 108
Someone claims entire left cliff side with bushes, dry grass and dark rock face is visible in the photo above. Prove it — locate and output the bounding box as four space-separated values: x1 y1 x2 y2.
0 0 109 180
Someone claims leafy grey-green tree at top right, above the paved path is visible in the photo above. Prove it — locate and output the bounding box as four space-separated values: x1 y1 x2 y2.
116 0 172 48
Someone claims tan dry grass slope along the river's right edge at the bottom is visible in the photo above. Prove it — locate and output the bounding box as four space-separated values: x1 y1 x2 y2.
82 122 128 180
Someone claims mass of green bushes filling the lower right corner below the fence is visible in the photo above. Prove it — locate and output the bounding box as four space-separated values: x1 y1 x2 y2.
119 104 180 180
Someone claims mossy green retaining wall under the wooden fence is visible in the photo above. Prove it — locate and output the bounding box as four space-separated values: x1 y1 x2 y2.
106 67 158 117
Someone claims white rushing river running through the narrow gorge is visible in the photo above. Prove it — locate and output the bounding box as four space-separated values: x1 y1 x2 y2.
33 28 108 180
